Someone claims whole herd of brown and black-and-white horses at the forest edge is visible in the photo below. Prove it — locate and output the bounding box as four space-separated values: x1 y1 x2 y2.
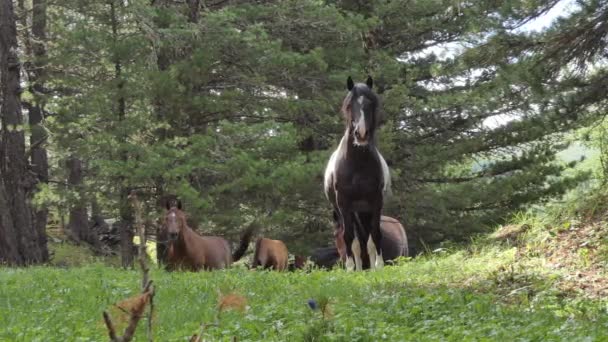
157 77 408 271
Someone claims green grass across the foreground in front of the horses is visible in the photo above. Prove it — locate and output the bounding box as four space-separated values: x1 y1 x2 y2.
0 244 608 341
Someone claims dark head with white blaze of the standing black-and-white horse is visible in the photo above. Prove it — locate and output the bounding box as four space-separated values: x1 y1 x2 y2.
342 76 380 146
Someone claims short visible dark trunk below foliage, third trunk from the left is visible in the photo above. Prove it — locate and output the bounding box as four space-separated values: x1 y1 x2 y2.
66 156 99 249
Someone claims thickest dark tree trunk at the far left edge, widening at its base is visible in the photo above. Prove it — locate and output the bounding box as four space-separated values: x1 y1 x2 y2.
0 0 48 264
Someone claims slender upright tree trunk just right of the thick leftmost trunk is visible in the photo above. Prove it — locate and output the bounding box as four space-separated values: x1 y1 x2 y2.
29 0 49 260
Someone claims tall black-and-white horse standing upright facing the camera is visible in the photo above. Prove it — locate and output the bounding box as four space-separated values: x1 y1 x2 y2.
324 76 390 271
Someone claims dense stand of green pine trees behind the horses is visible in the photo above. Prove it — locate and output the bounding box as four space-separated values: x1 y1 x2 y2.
25 0 606 260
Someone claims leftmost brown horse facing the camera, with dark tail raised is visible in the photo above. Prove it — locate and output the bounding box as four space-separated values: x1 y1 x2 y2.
161 202 253 271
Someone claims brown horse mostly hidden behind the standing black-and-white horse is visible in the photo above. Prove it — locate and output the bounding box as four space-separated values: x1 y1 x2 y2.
334 213 409 262
